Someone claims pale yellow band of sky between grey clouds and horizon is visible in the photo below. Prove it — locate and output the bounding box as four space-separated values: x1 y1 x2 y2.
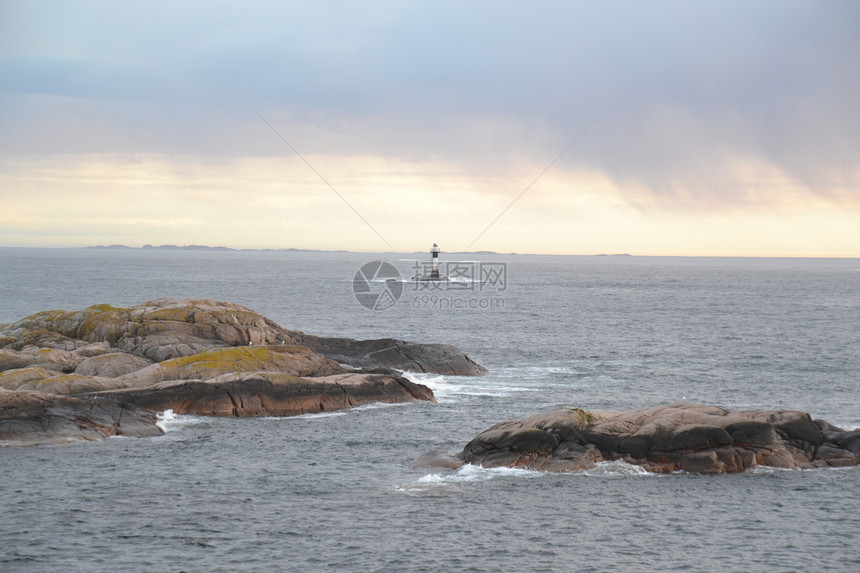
0 154 860 257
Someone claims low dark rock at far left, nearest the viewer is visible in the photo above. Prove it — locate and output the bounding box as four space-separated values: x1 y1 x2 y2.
0 389 163 446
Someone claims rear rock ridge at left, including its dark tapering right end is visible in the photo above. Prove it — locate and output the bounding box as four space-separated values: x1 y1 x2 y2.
0 298 486 376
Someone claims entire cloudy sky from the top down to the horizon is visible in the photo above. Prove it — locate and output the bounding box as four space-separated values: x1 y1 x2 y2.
0 0 860 257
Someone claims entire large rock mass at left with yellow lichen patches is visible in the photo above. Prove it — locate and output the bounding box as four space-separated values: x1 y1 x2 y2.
0 299 464 445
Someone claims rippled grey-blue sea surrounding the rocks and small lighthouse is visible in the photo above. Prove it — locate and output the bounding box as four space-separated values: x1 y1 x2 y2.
0 249 860 572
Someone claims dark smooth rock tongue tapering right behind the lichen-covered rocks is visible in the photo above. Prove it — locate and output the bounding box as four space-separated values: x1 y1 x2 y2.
293 333 487 376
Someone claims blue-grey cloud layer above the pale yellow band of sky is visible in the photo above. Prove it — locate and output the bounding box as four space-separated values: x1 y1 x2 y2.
0 1 860 203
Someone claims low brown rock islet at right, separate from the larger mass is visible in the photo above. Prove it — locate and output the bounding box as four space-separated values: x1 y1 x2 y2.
444 403 860 474
